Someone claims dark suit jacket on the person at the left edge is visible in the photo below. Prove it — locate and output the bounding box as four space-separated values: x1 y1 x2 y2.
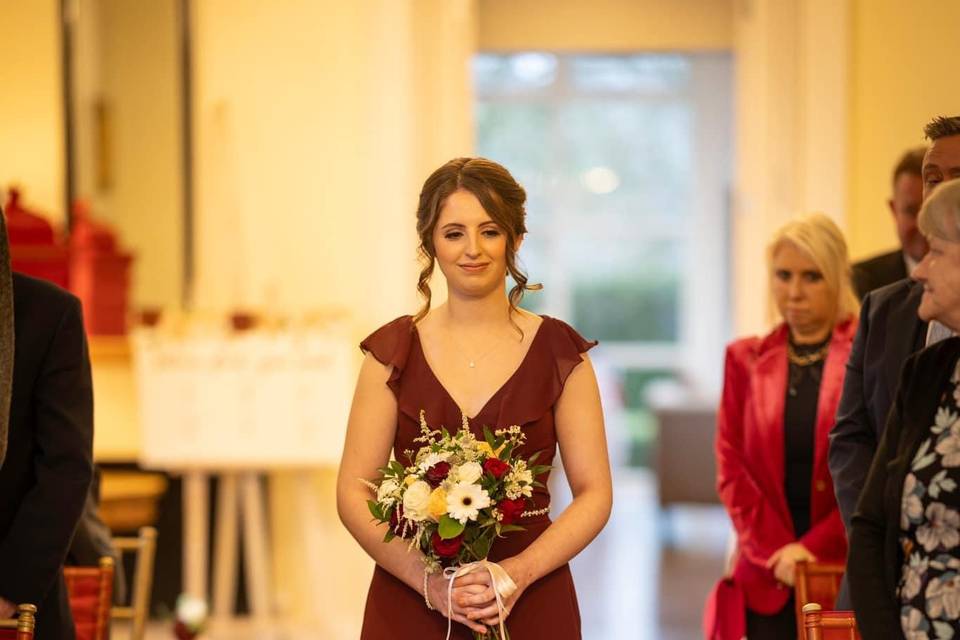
0 274 93 640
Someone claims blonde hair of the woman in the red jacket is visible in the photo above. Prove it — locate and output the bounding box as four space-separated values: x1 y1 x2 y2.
767 213 860 324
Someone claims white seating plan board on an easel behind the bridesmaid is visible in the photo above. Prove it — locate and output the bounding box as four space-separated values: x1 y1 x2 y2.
133 330 359 469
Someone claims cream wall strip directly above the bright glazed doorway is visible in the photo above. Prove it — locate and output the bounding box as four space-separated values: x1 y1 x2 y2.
478 0 738 51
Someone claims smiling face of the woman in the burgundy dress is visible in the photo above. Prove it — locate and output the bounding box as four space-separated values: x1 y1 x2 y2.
433 189 507 297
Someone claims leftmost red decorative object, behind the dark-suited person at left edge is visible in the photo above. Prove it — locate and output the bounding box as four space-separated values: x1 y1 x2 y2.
3 188 70 289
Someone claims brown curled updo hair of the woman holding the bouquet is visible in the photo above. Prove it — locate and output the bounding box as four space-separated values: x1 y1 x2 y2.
413 158 543 324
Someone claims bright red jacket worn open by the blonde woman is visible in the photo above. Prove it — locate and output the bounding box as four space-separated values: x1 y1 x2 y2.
707 319 857 640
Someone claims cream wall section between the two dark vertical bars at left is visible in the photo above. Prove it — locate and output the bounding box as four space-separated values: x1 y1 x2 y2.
94 0 183 308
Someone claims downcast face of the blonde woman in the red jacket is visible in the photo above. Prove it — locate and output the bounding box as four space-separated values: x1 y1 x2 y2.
771 242 836 340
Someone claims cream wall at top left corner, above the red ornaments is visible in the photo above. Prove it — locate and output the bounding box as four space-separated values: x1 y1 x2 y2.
0 0 66 225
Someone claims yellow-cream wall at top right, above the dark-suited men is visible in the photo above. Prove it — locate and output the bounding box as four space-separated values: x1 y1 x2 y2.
848 0 960 256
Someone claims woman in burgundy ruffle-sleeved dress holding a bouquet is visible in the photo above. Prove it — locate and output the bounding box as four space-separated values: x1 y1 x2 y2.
337 158 612 640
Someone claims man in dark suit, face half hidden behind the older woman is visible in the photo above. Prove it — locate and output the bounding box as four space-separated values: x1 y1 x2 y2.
828 116 960 609
